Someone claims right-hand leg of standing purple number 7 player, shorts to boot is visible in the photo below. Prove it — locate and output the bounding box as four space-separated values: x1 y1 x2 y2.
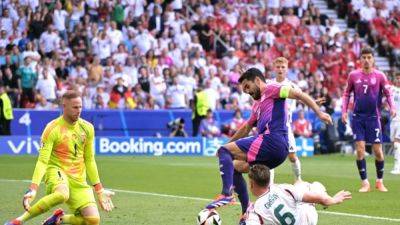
366 118 387 192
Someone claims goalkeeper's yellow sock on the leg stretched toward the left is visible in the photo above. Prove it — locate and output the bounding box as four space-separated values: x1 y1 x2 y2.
17 192 66 222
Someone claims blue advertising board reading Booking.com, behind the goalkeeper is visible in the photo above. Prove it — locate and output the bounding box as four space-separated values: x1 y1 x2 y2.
0 136 314 157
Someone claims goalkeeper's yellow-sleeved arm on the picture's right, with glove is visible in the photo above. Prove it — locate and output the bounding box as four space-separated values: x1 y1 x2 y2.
84 125 114 212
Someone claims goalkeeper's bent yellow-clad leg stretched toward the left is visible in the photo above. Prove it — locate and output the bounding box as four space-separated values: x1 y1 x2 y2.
6 168 69 222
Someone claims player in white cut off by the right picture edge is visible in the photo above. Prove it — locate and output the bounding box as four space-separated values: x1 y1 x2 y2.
390 72 400 174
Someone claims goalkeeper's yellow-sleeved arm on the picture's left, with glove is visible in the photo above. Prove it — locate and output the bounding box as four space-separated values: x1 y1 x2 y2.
22 125 55 211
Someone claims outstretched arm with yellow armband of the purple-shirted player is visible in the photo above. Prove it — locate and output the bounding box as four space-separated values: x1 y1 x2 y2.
279 86 333 124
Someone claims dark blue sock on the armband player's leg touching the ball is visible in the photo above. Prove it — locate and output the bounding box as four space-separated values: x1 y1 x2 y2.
218 147 233 196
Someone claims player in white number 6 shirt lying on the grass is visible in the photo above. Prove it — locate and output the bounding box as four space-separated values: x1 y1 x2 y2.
246 164 351 225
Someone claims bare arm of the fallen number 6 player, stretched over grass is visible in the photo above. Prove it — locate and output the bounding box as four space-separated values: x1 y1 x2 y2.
302 190 351 206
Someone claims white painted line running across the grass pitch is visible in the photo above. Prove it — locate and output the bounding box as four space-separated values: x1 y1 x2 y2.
0 179 400 222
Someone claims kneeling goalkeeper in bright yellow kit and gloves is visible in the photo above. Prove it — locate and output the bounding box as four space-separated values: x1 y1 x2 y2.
6 91 114 225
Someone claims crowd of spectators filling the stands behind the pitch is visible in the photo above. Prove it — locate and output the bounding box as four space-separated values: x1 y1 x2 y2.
0 0 400 118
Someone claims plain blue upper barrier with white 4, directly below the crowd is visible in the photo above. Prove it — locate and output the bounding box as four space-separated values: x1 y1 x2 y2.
11 109 340 137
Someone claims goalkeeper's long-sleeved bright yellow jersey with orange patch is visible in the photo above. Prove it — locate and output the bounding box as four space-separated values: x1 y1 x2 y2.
32 116 100 185
